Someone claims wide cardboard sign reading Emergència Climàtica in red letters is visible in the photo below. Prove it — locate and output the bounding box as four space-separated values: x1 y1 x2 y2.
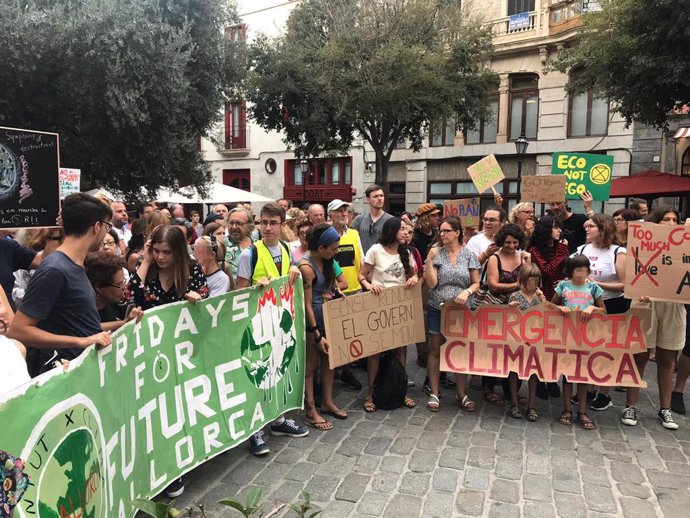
441 302 650 387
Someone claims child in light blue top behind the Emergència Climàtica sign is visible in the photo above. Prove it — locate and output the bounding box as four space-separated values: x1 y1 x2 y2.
551 254 606 430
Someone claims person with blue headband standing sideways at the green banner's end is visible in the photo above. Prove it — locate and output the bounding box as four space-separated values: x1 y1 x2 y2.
299 223 347 431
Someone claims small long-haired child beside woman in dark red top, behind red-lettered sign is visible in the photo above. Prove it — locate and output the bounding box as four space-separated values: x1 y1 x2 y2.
508 263 546 423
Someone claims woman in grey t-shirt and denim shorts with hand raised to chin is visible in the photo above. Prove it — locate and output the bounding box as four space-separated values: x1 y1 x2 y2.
424 216 481 412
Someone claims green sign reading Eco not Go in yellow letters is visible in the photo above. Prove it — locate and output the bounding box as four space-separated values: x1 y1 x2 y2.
551 153 613 201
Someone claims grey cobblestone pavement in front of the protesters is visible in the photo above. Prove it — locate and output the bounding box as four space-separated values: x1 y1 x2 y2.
173 362 690 518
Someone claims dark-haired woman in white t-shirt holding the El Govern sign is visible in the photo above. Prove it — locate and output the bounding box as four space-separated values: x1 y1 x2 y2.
359 218 419 412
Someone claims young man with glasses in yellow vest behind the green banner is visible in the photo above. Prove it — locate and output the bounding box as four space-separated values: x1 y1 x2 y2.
236 202 309 456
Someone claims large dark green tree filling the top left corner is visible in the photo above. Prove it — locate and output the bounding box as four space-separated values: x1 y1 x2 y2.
0 0 244 193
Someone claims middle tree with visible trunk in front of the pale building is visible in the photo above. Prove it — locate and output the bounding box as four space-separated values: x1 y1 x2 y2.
245 0 496 185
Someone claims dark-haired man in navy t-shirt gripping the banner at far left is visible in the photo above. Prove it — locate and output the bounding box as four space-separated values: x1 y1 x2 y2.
10 193 113 376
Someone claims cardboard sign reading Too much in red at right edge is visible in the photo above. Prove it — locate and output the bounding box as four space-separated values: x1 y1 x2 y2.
625 221 690 304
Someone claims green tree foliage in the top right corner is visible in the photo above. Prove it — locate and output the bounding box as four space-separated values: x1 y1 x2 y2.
553 0 690 127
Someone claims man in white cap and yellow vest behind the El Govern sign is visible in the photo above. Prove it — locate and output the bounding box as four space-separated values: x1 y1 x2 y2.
328 200 364 390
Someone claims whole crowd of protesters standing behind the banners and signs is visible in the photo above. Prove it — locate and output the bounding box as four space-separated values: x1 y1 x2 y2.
0 185 690 496
